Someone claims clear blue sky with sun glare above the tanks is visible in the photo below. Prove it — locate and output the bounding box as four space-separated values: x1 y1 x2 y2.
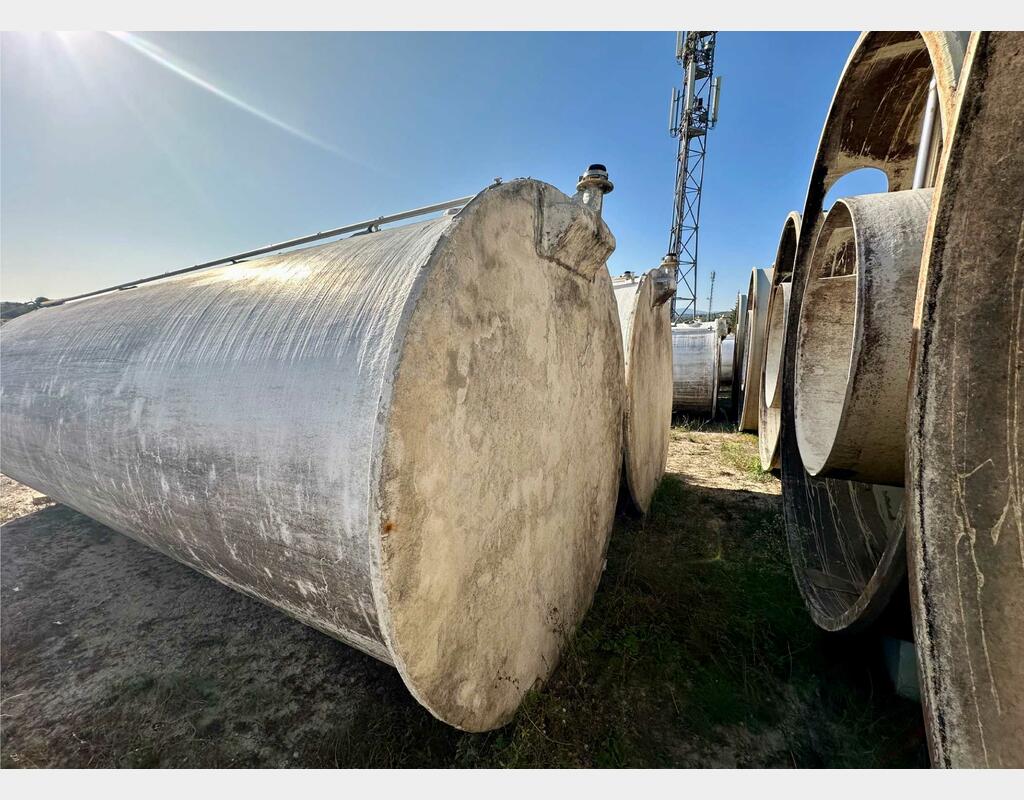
0 32 871 308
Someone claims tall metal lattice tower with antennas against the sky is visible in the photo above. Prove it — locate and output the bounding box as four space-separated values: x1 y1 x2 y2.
665 31 722 321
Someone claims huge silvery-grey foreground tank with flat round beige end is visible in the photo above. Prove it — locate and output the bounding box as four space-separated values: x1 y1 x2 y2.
0 179 624 730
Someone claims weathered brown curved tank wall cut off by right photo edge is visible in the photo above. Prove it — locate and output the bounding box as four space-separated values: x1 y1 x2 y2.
907 32 1024 768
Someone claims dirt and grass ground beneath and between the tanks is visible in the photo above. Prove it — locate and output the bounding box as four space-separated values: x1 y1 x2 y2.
0 424 927 767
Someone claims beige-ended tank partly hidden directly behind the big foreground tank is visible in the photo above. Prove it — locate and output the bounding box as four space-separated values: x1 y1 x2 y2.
612 268 676 514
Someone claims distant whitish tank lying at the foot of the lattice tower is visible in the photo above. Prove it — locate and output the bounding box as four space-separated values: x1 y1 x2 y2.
672 325 721 417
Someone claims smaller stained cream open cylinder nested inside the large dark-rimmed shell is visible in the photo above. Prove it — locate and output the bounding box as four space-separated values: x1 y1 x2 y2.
793 188 933 483
